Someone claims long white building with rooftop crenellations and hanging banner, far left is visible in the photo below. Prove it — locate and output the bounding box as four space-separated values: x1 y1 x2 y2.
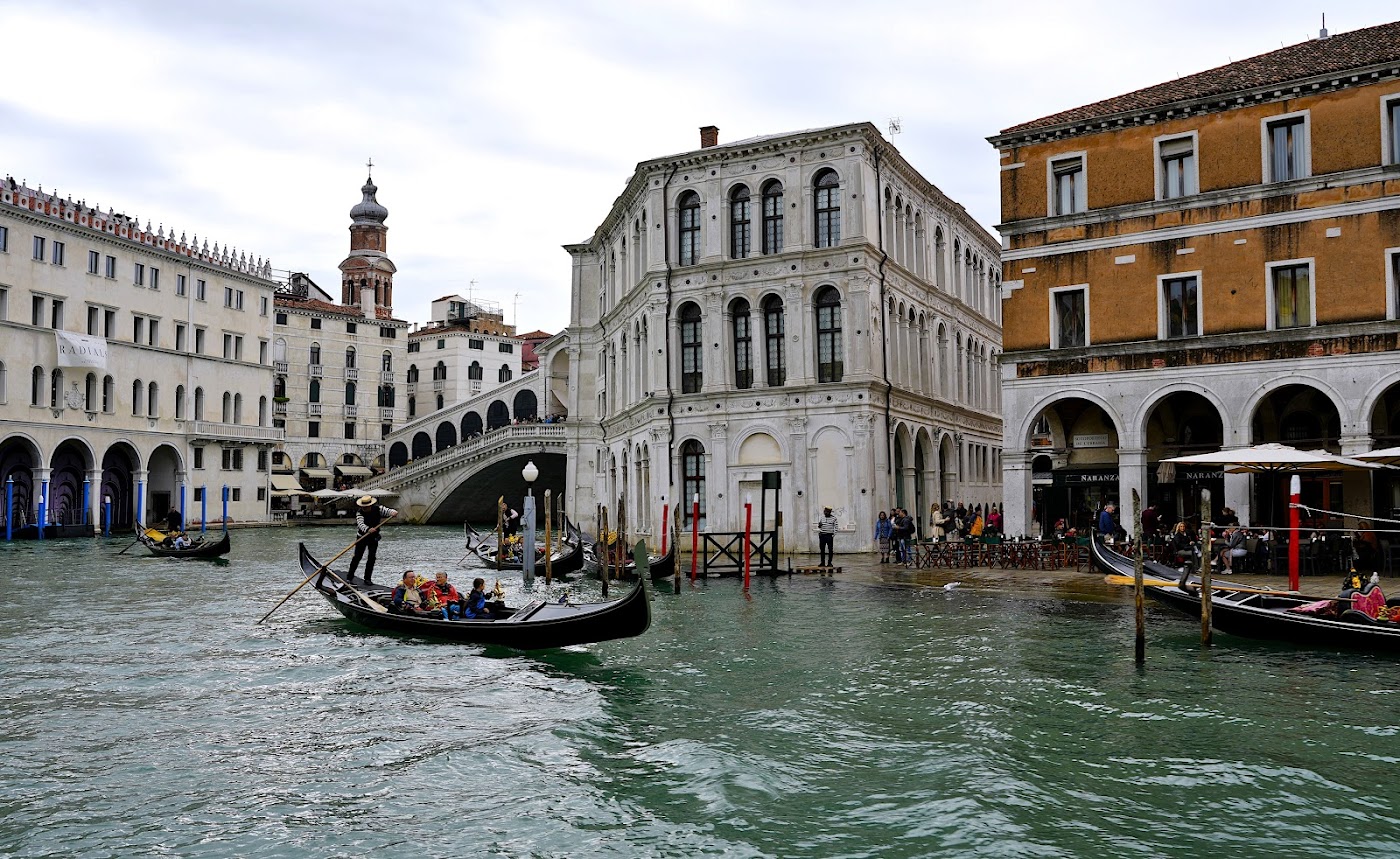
0 179 283 533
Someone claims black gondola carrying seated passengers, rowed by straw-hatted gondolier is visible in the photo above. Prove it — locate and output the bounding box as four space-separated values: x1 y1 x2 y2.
300 544 651 651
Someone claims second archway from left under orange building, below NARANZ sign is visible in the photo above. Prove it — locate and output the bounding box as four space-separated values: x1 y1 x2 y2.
1142 390 1225 530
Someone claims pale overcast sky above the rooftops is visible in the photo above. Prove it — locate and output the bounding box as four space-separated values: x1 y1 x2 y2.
0 0 1400 332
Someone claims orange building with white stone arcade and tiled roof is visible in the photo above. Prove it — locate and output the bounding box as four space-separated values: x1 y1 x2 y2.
988 22 1400 533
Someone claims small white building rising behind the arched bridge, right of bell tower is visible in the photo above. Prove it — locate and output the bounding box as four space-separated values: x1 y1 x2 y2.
407 295 525 418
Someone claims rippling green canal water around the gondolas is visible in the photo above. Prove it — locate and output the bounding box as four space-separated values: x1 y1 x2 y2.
0 527 1400 858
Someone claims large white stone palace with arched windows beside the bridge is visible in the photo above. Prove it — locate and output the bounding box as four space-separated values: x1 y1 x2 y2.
539 123 1001 551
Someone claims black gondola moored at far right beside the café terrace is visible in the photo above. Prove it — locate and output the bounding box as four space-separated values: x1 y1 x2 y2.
1091 540 1400 652
